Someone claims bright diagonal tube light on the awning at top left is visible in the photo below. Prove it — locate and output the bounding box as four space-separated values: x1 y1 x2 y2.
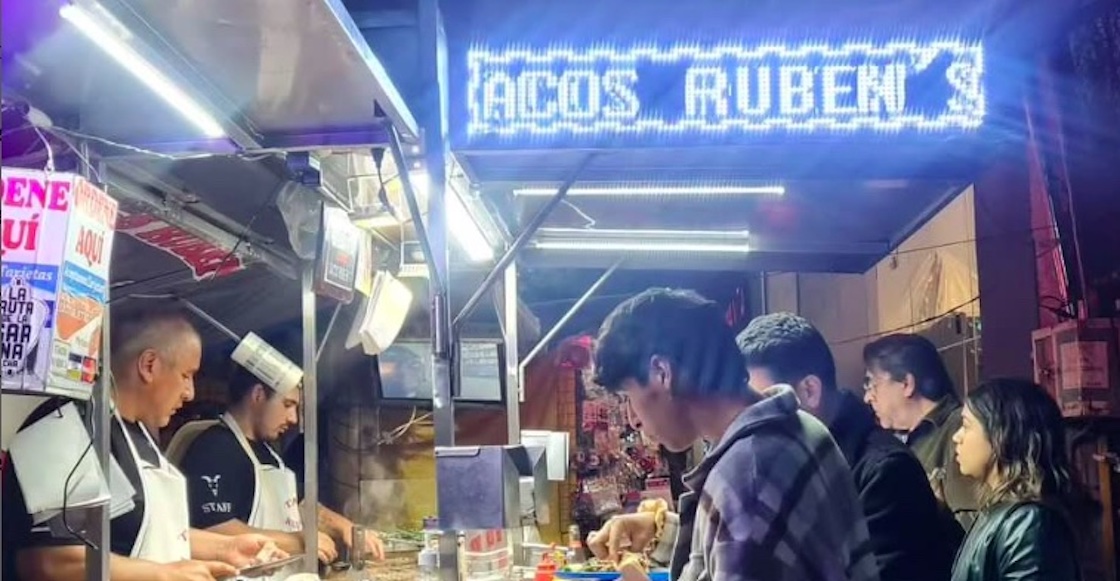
58 4 225 139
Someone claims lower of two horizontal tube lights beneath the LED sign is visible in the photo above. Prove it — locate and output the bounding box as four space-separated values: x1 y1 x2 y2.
531 228 750 254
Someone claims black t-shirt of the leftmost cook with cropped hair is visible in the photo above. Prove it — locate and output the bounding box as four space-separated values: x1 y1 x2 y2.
2 397 160 579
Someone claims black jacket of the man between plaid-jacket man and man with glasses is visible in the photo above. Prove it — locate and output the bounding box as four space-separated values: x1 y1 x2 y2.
829 392 964 581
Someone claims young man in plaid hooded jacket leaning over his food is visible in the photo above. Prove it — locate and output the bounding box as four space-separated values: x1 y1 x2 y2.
590 289 879 581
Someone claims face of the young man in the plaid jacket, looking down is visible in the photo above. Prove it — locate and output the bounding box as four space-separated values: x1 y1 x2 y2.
619 357 699 452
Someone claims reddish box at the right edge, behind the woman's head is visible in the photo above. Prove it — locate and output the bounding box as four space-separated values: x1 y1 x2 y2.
1032 319 1120 418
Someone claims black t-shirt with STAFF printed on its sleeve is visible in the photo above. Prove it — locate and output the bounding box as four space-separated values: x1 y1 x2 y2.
179 423 304 528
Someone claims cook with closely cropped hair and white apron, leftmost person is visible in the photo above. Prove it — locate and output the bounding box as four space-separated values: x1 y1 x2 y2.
2 309 282 581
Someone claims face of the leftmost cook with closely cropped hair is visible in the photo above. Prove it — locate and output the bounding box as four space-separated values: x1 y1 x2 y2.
137 334 203 429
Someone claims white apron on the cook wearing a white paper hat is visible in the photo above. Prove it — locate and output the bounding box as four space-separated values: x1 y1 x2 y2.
222 414 304 581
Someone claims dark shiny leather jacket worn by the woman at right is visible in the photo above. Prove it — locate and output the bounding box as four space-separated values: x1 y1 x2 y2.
952 503 1081 581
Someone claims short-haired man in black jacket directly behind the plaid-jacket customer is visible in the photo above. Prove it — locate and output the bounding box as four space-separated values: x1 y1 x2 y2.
738 312 963 581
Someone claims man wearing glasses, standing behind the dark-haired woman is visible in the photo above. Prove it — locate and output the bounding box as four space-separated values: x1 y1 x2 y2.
864 334 977 531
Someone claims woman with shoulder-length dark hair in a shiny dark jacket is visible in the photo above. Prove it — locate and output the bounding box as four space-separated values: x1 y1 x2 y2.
952 379 1081 581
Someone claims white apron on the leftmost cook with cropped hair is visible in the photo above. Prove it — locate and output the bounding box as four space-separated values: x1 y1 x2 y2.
113 411 190 563
